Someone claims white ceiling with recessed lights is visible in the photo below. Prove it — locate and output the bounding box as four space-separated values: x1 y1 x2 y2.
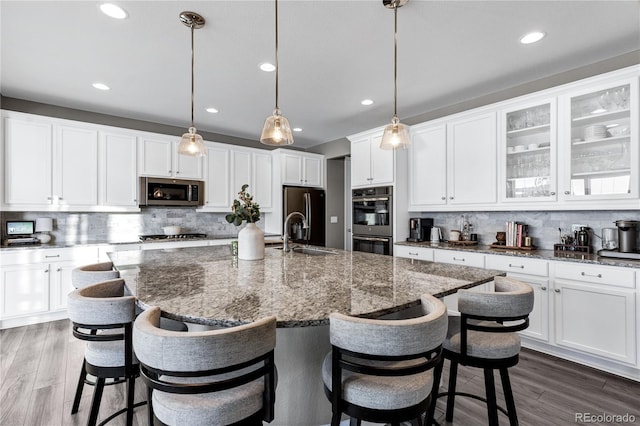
0 0 640 148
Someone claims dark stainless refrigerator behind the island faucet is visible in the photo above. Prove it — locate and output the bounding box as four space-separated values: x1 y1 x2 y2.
282 186 325 247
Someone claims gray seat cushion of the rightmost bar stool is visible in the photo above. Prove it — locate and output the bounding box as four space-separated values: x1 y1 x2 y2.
442 316 520 359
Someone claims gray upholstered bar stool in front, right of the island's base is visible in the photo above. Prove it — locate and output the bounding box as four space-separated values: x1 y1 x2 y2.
322 295 447 426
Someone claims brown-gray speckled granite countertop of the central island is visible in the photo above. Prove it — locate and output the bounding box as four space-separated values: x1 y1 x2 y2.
109 246 505 327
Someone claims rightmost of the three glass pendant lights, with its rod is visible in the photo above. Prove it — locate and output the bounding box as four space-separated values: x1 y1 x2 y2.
380 0 411 150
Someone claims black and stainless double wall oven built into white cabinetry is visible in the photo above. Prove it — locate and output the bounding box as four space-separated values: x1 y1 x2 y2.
351 186 393 255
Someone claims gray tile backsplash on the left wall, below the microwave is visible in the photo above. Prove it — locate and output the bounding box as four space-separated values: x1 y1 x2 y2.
0 207 264 244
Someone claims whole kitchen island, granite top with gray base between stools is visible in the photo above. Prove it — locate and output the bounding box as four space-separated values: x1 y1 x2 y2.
109 246 505 426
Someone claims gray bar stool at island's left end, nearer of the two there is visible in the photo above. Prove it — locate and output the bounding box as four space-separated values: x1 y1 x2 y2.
67 278 140 425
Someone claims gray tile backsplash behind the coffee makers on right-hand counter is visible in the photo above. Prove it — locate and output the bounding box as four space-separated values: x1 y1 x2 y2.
407 210 640 250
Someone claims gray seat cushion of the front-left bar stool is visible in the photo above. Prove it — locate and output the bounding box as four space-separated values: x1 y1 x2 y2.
152 369 264 426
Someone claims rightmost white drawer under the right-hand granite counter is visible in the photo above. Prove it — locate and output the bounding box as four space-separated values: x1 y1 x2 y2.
555 262 635 288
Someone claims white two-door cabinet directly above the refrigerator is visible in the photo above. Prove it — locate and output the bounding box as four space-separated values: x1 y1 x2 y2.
278 150 324 187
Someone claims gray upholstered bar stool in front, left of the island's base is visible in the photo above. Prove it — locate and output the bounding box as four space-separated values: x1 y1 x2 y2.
133 307 276 426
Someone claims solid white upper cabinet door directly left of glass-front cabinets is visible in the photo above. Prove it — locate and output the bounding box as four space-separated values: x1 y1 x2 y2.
448 111 497 205
